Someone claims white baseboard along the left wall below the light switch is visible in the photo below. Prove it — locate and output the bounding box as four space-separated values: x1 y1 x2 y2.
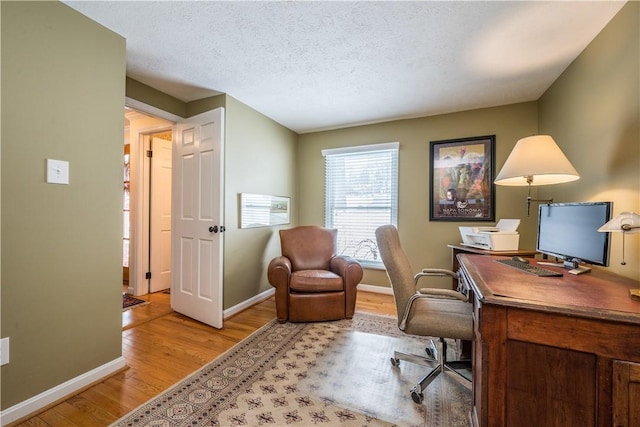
0 356 127 426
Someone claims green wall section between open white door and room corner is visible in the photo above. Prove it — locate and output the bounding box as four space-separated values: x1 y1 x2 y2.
224 96 299 308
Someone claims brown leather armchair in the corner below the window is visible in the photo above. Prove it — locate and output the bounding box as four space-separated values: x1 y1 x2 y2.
268 225 362 323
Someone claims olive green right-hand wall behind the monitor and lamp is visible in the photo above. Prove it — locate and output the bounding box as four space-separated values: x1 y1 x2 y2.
539 1 640 280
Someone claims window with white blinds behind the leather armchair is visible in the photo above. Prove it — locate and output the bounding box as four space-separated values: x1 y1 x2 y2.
322 142 399 267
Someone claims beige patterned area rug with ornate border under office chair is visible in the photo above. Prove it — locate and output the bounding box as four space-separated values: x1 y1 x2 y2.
113 313 471 427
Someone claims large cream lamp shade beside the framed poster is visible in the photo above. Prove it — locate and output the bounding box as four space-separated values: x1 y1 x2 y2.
495 135 580 186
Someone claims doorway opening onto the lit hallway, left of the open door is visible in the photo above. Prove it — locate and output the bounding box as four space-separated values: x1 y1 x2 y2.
123 107 173 296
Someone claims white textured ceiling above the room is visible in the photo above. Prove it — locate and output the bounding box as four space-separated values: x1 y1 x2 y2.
64 1 625 133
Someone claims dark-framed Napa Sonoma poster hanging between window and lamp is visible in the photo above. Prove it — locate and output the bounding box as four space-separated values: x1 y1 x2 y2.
429 135 496 221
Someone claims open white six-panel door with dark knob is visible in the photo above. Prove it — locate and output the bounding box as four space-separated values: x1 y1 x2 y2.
171 108 224 328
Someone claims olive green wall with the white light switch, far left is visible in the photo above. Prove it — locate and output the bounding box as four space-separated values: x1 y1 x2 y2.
1 1 125 409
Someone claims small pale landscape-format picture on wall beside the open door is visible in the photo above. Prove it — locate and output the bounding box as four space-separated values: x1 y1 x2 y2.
240 193 291 228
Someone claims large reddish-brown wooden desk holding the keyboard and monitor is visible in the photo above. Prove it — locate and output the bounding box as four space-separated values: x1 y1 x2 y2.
458 254 640 427
